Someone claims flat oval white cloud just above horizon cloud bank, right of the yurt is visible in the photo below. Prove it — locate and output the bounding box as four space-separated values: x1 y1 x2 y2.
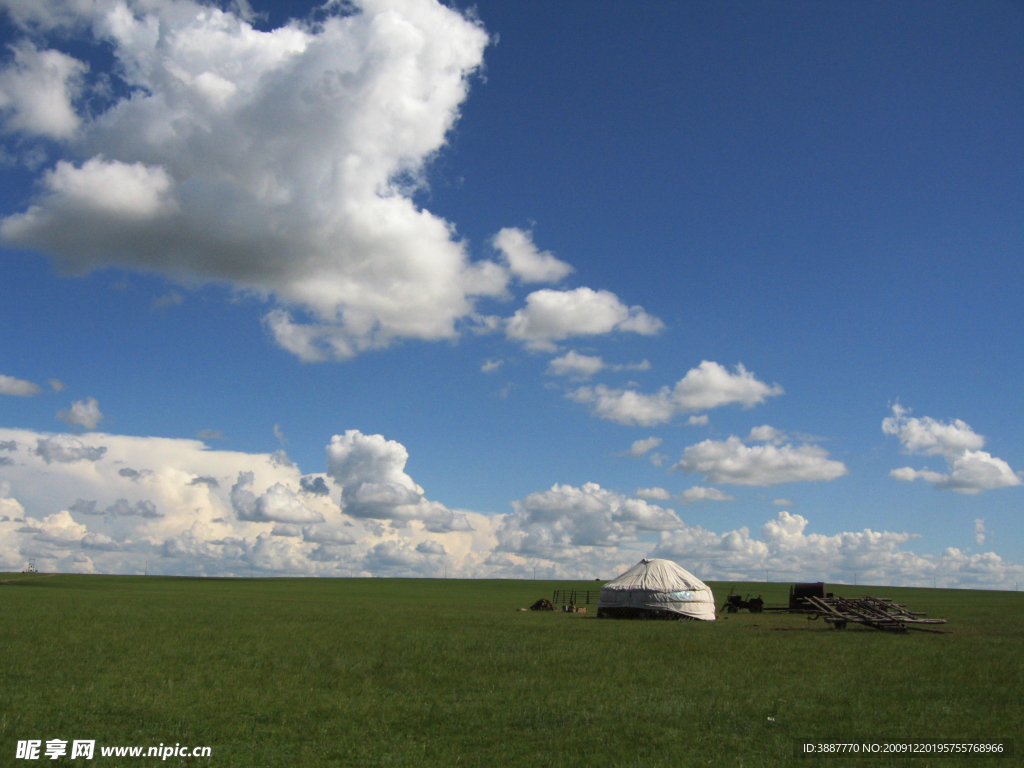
673 435 848 485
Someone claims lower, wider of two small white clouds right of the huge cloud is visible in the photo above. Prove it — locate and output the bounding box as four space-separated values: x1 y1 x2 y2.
505 287 665 352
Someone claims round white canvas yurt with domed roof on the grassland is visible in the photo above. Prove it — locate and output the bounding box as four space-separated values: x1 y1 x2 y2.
597 559 715 622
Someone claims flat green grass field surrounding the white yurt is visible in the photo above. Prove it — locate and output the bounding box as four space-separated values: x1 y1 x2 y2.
0 573 1024 768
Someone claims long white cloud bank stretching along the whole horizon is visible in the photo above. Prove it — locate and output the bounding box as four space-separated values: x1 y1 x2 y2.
0 429 1024 589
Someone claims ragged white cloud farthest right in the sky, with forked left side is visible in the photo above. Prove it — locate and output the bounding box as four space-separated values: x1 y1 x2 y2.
882 404 1022 494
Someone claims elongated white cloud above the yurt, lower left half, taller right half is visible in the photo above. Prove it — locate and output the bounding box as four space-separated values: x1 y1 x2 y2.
568 360 782 426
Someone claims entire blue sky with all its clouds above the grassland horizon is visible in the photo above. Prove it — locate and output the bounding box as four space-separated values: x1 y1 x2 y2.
0 0 1024 589
